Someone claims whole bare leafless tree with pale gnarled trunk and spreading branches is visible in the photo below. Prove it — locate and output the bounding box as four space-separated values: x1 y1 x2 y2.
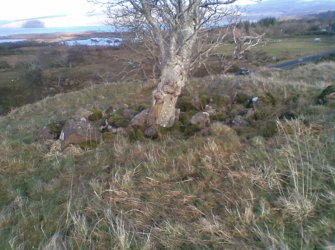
92 0 257 133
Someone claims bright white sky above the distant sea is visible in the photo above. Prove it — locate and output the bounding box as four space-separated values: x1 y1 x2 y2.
0 0 326 28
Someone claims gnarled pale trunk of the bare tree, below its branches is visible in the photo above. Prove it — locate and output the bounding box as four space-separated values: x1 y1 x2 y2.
148 56 187 129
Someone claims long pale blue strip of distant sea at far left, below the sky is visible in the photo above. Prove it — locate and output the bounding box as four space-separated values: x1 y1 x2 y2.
0 26 113 38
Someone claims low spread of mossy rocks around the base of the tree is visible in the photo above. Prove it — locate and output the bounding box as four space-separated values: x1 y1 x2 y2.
40 83 322 150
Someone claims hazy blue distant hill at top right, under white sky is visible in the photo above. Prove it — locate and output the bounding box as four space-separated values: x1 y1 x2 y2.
244 0 335 20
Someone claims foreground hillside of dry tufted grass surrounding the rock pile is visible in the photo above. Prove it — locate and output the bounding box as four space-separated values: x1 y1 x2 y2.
0 63 335 249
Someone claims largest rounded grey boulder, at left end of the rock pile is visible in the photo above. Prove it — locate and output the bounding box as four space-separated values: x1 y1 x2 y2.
59 117 101 148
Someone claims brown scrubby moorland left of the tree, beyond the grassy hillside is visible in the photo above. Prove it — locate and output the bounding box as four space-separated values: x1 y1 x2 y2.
0 44 152 114
